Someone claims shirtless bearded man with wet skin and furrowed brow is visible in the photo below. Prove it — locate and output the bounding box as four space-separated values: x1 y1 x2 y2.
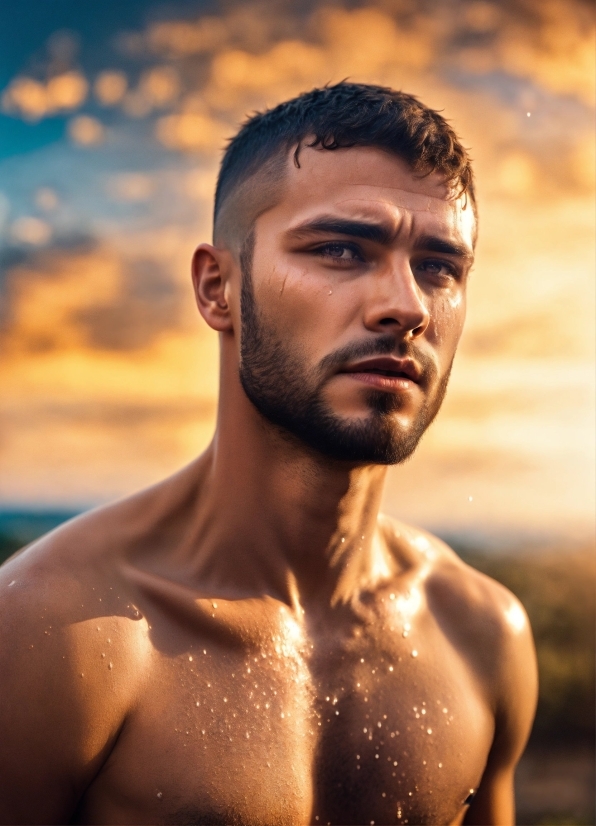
0 83 536 826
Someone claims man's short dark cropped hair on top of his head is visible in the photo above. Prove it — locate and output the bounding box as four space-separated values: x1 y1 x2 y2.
214 81 476 227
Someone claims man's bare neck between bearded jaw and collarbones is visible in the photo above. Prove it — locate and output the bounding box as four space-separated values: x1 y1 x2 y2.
184 376 390 606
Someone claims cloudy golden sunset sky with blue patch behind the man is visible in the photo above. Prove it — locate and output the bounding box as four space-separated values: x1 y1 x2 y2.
0 0 595 541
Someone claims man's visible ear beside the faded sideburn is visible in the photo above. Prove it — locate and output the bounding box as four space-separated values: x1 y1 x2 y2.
192 244 233 333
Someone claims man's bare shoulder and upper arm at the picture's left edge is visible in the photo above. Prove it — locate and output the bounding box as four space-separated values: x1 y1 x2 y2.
0 492 161 823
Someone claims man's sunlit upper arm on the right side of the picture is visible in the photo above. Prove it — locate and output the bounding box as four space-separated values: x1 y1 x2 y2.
464 593 538 826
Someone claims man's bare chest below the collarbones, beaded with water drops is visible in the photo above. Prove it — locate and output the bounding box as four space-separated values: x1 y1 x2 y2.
81 624 492 826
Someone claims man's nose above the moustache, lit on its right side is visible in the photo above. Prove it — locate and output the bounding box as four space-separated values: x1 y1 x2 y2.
364 261 430 338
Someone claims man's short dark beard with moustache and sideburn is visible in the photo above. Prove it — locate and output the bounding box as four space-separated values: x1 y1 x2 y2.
240 245 451 465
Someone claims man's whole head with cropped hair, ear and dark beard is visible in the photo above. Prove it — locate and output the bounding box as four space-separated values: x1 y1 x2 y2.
195 83 476 464
